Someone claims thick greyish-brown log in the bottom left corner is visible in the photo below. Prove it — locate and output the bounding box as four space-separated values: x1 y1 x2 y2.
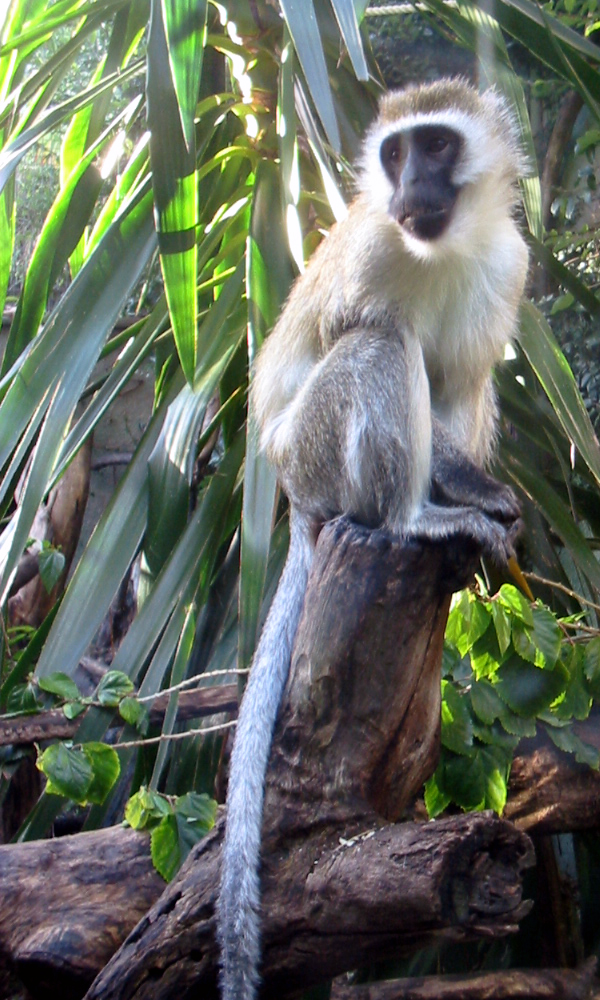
0 827 165 1000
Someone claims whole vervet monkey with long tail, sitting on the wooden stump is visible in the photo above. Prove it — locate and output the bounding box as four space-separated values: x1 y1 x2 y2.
218 80 527 1000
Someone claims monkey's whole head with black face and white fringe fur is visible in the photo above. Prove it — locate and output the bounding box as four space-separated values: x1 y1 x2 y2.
361 79 524 258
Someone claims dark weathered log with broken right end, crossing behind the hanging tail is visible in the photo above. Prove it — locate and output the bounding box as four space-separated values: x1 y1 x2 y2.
75 813 533 1000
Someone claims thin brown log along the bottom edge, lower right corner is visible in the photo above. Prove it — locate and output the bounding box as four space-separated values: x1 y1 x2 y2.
331 959 600 1000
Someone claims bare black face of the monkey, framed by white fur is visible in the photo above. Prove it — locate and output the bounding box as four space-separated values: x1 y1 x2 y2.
379 125 463 240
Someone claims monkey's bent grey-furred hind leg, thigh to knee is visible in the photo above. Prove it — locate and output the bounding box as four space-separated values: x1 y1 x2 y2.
278 329 431 533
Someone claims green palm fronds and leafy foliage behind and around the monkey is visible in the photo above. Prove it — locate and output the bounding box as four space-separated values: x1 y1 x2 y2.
0 0 600 984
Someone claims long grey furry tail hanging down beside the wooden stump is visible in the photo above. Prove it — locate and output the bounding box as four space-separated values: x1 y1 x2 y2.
217 516 313 1000
